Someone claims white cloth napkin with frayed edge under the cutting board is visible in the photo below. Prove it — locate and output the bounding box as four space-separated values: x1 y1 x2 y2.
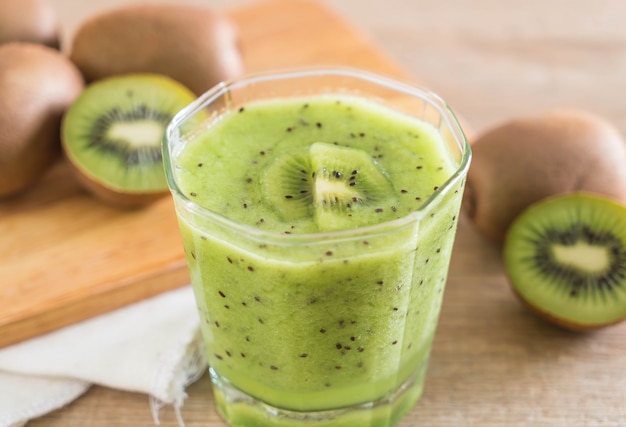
0 286 206 427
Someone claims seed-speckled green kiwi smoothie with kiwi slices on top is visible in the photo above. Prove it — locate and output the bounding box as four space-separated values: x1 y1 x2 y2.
168 95 463 426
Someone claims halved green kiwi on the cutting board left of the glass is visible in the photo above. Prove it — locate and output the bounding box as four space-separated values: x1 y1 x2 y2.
61 74 195 206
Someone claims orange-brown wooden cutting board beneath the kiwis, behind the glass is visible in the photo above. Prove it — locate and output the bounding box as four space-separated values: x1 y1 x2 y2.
0 0 412 347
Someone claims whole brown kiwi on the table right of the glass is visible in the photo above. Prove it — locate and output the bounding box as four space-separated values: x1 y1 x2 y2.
463 109 626 245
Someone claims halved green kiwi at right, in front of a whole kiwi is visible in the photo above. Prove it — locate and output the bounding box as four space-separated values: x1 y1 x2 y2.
504 193 626 330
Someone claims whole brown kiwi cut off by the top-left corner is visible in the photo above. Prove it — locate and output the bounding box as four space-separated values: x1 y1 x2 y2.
0 0 61 49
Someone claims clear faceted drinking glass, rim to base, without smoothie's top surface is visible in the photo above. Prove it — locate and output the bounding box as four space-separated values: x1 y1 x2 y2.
163 68 471 427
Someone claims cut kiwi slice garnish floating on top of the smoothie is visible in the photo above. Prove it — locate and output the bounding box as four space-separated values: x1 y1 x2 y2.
263 142 397 231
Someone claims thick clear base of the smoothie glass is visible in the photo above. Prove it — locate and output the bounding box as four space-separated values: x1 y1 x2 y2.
209 368 425 427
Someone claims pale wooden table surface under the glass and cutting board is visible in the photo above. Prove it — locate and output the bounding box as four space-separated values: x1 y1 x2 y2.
28 0 626 427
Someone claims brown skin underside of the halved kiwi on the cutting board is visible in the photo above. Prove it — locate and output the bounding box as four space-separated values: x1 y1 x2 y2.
67 158 169 210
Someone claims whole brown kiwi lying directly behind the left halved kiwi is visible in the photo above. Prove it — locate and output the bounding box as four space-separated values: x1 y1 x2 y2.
70 4 243 95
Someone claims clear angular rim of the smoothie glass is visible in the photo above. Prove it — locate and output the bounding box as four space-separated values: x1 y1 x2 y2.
162 66 471 244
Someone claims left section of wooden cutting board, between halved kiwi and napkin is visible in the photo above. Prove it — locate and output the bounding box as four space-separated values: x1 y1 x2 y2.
0 152 189 347
